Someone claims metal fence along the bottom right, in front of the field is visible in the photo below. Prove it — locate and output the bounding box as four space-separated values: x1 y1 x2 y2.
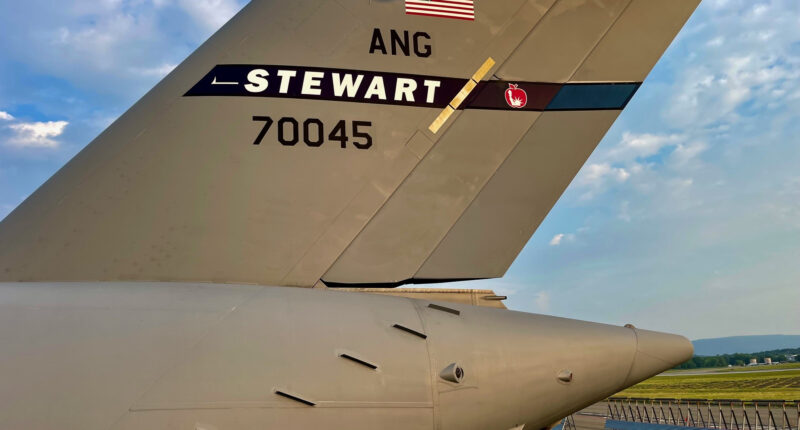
607 397 800 430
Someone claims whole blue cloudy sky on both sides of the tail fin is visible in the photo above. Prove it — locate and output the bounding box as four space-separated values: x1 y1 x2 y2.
0 0 800 339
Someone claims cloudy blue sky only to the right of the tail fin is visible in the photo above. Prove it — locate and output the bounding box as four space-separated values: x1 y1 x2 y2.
466 0 800 338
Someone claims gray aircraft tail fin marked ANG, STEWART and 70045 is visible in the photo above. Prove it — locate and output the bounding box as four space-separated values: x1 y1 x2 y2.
0 0 699 287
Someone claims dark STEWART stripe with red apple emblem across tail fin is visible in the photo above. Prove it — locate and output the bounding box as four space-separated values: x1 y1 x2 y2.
185 64 641 112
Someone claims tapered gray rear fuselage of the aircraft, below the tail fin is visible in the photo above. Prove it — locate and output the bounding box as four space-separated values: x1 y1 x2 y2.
0 283 691 430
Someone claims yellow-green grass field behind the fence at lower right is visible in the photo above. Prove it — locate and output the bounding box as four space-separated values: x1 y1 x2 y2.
618 368 800 400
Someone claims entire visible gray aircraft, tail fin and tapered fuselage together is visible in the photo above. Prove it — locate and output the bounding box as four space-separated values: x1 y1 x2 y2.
0 0 698 430
